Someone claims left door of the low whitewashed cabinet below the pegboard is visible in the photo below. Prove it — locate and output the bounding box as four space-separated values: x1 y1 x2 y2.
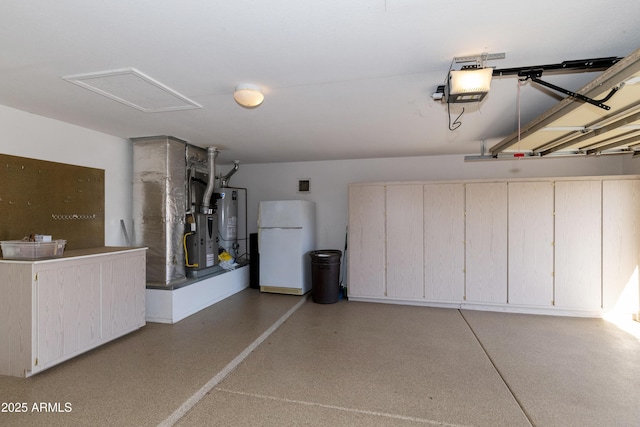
35 262 100 368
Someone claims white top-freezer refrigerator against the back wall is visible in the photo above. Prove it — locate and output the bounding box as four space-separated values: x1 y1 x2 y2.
258 200 316 295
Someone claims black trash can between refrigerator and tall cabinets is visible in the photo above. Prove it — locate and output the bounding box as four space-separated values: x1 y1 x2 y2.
309 249 342 304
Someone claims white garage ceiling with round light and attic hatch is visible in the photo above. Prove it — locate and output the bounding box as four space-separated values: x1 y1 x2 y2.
0 0 640 164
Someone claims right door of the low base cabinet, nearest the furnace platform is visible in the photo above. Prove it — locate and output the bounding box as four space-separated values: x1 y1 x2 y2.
102 252 146 340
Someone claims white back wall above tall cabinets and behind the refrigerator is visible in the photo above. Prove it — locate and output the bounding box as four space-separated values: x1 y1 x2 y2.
230 156 624 256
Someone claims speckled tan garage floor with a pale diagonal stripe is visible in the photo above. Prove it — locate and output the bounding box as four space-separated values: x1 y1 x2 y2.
0 289 640 426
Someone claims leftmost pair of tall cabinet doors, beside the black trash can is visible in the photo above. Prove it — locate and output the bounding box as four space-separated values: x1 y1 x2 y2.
348 185 424 299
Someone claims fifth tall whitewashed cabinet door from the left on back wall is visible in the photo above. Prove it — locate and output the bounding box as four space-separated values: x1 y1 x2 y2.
508 182 553 306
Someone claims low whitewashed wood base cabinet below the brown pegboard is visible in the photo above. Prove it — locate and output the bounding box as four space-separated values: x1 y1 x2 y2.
0 248 146 377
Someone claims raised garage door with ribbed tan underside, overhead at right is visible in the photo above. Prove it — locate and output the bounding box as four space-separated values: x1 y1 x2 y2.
489 49 640 157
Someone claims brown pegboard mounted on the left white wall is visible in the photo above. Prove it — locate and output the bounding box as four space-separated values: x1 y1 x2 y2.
0 154 104 249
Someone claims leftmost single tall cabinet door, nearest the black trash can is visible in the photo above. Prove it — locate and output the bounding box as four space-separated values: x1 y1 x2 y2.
347 185 385 296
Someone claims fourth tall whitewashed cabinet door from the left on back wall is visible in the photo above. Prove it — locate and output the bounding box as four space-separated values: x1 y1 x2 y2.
466 182 507 304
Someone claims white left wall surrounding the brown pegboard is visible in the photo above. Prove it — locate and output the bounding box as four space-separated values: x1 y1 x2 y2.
0 105 132 246
